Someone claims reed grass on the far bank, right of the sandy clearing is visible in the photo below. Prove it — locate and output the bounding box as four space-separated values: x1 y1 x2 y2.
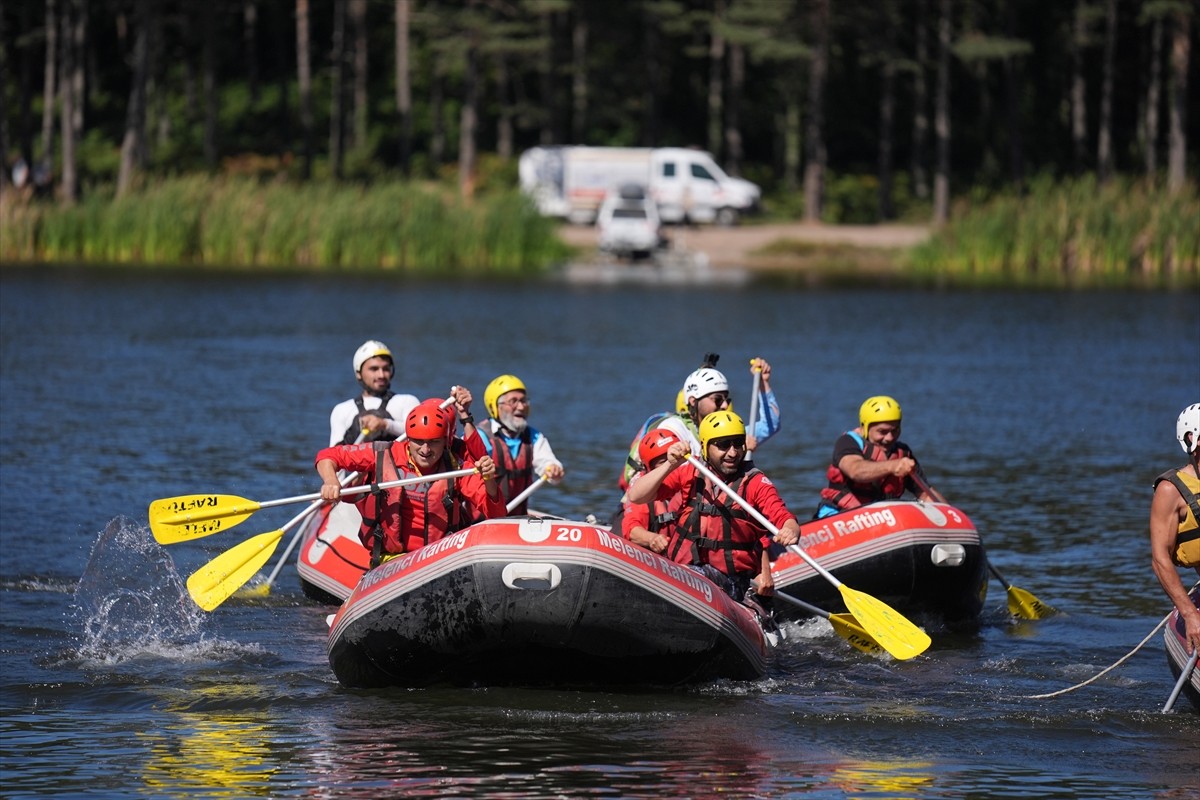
906 176 1200 288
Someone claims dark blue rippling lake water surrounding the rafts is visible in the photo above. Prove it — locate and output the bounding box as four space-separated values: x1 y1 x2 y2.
0 270 1200 800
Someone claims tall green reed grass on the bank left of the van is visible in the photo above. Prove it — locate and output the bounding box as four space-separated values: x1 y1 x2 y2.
0 175 569 276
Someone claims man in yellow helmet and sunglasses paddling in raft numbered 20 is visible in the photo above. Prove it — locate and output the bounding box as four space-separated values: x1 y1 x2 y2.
629 411 800 622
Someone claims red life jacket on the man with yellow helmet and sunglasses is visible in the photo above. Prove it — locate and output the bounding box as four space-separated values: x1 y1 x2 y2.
665 467 764 577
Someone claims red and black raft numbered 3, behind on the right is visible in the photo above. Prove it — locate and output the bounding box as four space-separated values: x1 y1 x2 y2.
772 500 988 622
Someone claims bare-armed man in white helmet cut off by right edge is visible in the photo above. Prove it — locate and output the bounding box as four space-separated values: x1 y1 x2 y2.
1150 403 1200 652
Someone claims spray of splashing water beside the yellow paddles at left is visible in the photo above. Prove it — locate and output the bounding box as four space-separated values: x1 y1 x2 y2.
74 517 204 663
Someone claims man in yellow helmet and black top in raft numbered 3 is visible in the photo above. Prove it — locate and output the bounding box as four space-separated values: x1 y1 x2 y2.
814 395 946 519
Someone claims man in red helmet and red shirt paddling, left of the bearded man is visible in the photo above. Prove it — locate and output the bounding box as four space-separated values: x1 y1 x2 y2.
316 401 506 566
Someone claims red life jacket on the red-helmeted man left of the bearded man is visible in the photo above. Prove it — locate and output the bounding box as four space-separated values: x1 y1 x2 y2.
355 441 474 566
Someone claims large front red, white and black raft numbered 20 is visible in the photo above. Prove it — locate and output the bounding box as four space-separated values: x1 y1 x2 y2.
329 517 768 687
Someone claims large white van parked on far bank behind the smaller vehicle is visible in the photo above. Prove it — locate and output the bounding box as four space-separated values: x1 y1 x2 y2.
518 146 762 224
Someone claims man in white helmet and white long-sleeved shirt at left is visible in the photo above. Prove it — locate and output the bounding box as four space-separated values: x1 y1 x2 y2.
329 339 418 445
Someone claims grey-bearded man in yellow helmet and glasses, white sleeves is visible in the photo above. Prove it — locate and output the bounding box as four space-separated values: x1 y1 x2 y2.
458 374 564 516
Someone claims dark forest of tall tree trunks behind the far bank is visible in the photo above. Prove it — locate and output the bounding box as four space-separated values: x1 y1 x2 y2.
0 0 1200 284
